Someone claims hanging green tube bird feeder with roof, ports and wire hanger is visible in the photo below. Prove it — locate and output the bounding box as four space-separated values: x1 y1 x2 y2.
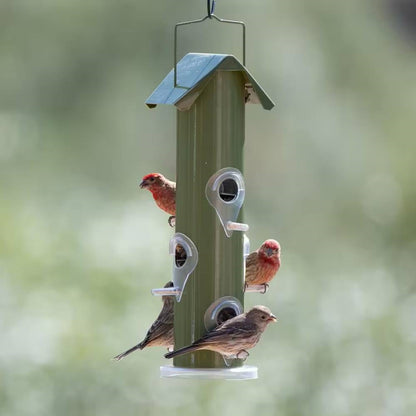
146 2 274 379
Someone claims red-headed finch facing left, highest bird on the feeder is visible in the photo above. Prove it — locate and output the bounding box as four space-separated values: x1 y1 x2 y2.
140 173 176 225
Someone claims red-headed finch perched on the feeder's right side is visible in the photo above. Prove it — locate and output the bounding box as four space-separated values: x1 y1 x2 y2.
246 240 280 291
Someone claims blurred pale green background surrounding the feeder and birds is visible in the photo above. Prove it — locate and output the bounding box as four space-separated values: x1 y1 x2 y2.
0 0 416 416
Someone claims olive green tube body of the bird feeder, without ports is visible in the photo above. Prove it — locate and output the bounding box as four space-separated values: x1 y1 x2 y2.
173 70 245 368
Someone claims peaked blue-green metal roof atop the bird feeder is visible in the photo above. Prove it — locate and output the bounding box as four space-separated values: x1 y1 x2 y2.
146 53 274 110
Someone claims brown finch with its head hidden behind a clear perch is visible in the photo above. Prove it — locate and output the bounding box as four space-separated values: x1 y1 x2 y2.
114 282 174 361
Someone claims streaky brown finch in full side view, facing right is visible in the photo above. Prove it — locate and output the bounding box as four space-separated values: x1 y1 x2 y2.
165 305 277 358
